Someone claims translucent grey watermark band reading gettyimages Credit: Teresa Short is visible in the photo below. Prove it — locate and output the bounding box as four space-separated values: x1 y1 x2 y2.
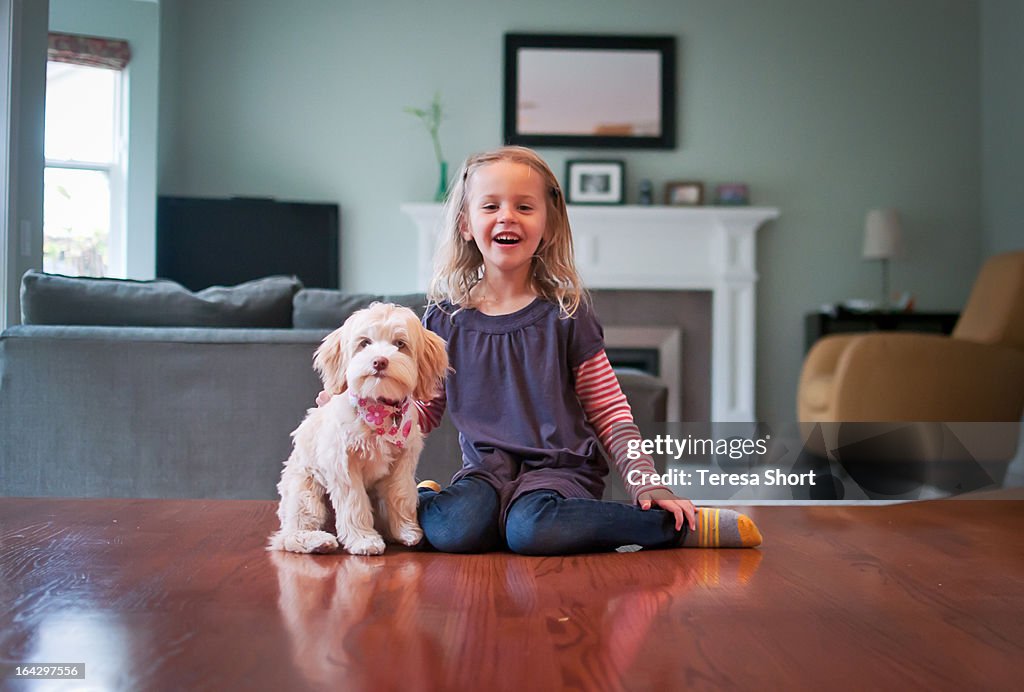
610 422 1024 503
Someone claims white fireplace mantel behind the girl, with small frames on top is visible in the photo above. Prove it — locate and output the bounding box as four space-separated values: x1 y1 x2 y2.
401 204 778 422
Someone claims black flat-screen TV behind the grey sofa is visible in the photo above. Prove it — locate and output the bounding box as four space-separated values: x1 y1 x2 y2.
157 197 341 291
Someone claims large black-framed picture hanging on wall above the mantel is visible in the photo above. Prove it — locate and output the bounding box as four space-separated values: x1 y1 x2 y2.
504 34 677 149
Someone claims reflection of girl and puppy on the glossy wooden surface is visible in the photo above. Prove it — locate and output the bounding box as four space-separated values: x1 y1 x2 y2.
269 550 762 689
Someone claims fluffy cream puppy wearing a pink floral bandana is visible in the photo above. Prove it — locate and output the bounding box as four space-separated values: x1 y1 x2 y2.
267 303 447 555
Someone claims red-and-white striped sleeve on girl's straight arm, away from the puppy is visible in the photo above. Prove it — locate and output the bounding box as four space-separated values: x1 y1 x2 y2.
575 349 669 502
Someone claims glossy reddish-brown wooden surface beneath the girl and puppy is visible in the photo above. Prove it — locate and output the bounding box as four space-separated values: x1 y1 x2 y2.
0 499 1024 691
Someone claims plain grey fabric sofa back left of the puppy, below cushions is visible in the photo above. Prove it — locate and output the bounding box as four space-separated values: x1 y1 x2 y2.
0 326 325 499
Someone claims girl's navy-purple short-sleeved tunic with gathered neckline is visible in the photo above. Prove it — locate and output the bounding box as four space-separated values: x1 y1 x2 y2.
423 298 608 525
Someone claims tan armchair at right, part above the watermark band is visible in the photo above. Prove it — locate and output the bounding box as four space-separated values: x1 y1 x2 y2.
797 251 1024 423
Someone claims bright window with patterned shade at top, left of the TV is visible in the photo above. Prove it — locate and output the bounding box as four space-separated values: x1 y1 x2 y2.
43 34 127 276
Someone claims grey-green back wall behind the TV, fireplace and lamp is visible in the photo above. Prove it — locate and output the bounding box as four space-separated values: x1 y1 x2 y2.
159 0 987 420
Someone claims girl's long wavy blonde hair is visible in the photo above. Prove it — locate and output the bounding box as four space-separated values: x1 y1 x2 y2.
427 146 587 317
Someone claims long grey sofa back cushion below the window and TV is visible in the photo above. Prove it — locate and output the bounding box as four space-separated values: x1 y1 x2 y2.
22 271 302 329
